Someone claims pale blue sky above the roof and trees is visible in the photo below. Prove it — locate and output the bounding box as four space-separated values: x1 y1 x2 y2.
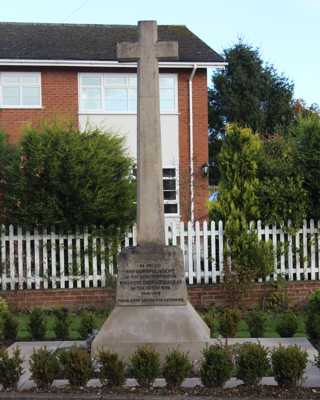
0 0 320 105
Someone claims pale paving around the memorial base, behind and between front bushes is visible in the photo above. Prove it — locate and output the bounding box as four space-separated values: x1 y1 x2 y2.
9 338 320 391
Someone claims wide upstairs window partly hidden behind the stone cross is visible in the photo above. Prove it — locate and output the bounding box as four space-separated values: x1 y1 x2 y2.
79 73 177 114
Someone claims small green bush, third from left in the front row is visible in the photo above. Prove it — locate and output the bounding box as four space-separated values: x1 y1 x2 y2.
59 346 93 387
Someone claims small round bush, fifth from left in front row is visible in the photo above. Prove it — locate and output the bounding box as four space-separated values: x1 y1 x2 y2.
129 345 161 388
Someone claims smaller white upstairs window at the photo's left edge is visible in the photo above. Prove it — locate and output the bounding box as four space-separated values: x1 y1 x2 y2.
0 72 41 108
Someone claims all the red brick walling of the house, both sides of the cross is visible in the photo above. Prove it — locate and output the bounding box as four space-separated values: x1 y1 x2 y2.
0 68 208 222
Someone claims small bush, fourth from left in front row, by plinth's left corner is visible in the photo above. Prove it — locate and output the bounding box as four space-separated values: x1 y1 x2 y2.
98 351 125 387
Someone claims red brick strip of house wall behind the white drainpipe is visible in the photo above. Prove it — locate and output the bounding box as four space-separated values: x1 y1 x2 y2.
178 70 209 222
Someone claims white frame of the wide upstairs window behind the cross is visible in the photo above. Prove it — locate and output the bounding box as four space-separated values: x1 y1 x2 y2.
78 72 178 115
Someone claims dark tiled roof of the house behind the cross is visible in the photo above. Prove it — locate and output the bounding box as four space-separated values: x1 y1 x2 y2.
0 22 224 63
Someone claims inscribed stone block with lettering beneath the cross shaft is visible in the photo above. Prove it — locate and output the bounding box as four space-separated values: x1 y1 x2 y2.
117 247 187 306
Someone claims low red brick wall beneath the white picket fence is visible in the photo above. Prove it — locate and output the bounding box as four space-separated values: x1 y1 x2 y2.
0 281 320 310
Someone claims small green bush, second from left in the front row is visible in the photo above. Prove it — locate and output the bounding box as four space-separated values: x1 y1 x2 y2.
30 347 59 389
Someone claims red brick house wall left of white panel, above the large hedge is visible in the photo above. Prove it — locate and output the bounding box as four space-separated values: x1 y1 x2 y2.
0 69 78 143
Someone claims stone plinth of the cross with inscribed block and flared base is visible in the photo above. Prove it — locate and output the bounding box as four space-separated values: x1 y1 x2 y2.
92 246 210 360
